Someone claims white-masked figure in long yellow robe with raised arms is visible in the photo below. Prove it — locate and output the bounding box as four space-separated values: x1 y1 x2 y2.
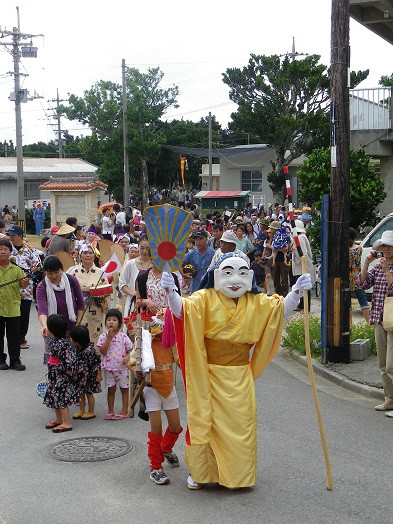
161 253 311 489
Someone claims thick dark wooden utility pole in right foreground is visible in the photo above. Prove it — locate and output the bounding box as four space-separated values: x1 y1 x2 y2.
327 0 351 362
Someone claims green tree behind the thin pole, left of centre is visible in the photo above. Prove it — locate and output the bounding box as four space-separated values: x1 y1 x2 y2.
60 67 178 204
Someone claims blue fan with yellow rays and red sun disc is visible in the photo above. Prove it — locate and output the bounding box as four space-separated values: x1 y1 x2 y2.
143 204 192 271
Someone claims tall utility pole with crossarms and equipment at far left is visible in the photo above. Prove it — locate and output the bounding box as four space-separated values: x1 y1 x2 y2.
0 7 43 230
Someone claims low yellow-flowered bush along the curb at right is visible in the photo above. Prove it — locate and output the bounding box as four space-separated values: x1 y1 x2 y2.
282 315 376 360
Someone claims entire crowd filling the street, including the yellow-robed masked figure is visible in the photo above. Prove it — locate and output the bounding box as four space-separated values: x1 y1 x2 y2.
0 195 393 489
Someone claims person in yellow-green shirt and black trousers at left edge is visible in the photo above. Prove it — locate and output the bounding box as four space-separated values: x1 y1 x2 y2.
0 238 30 371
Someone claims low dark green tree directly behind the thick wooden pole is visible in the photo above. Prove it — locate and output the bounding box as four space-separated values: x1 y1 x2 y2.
297 148 387 228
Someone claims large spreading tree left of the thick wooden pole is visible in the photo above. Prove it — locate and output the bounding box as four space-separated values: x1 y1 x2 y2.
223 54 368 199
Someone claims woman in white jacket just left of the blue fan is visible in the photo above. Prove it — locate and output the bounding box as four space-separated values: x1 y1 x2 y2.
119 236 153 317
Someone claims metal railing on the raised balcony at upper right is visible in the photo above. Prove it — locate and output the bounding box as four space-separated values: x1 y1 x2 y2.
349 87 392 131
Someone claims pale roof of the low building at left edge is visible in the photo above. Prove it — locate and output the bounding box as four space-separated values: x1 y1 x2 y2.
0 157 97 174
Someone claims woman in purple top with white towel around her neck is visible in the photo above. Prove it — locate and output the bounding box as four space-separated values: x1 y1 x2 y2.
36 255 85 364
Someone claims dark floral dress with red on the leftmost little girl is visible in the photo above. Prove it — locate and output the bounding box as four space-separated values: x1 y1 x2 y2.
44 338 79 409
